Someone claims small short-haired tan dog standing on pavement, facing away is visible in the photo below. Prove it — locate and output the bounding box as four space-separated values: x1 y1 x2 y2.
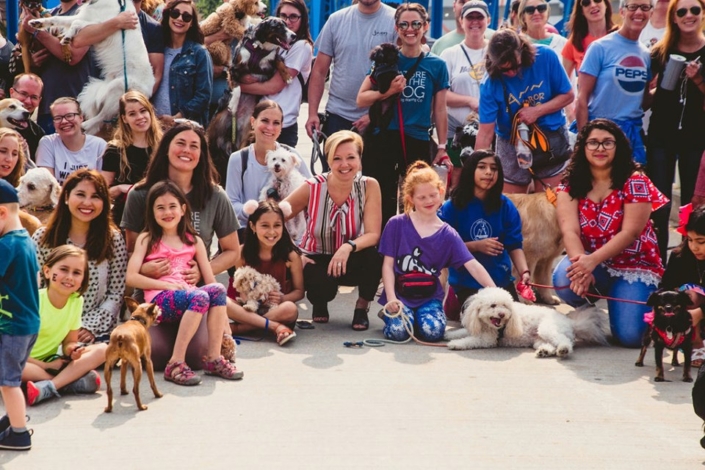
104 297 162 413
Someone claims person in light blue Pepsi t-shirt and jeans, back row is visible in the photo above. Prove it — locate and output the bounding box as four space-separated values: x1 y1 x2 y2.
575 0 653 164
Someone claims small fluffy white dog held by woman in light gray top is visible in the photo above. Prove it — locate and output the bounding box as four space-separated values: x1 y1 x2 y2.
259 147 306 240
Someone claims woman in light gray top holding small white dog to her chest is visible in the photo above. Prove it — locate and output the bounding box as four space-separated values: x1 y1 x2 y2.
225 99 311 230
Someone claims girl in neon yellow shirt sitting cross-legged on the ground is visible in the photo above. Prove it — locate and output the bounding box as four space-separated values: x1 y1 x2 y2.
22 245 107 406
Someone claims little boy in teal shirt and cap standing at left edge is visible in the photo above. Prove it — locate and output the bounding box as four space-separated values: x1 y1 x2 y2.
0 179 39 450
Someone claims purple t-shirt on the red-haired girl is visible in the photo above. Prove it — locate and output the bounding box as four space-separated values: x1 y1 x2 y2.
379 214 474 308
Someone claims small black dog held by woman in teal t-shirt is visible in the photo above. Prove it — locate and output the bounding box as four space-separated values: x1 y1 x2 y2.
368 42 401 131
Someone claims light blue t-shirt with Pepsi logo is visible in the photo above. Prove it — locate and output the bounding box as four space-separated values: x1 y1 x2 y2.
580 32 651 121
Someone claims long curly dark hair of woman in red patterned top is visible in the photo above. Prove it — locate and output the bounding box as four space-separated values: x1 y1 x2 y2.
563 119 641 199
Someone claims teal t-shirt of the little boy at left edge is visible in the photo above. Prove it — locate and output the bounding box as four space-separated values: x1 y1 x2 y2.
0 229 39 336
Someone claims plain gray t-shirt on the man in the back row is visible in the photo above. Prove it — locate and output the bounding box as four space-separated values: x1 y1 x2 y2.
316 4 397 121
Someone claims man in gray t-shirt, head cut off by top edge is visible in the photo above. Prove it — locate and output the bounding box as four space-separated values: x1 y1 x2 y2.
306 0 396 160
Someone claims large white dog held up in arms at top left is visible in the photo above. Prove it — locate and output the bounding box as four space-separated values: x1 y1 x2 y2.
30 0 154 134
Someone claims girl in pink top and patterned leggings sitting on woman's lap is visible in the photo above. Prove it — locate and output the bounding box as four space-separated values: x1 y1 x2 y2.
127 180 243 385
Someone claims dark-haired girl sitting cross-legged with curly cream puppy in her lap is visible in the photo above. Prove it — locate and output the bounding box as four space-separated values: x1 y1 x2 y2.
228 200 304 346
